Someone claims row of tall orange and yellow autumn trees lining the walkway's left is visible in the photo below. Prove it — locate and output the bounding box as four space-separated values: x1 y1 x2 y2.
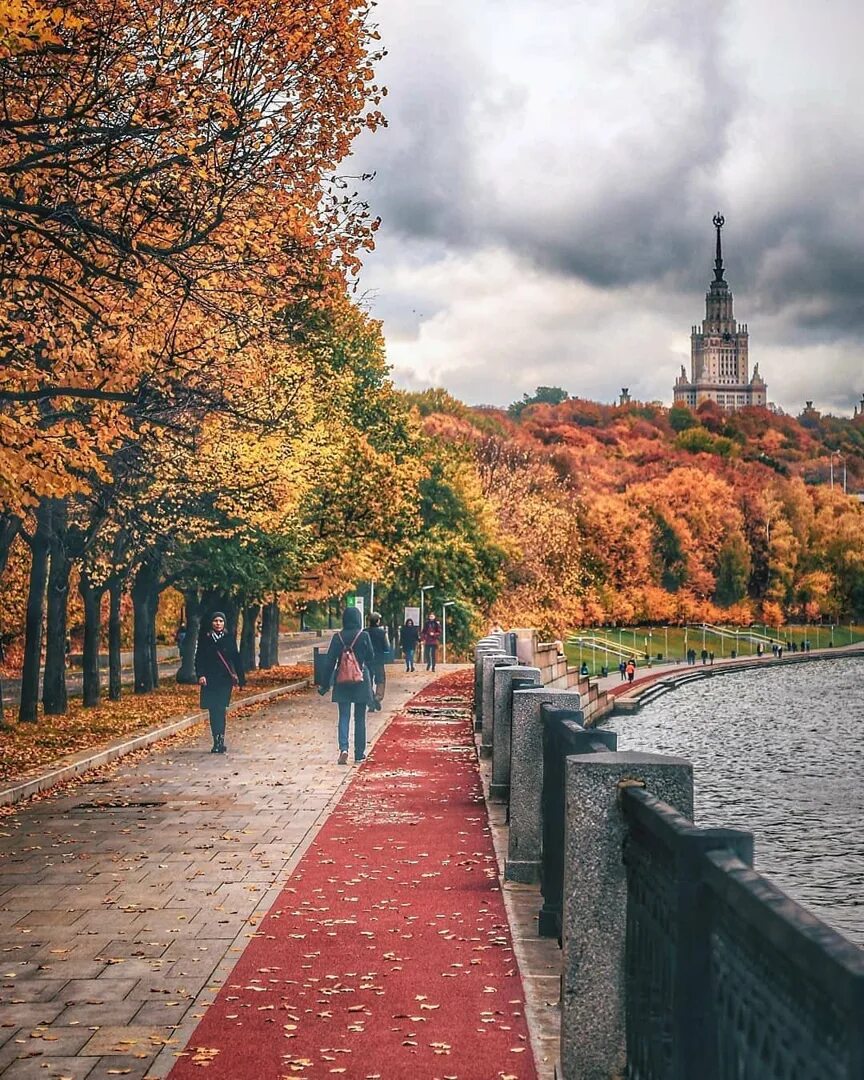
0 0 505 721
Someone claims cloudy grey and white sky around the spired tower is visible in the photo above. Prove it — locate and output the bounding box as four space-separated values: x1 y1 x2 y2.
350 0 864 415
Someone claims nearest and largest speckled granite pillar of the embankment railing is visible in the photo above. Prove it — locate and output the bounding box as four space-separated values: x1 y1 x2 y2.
561 751 693 1080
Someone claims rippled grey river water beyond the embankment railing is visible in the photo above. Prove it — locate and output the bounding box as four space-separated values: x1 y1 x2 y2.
605 657 864 946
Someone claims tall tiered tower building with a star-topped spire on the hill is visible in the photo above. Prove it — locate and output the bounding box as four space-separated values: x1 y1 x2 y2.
674 214 767 409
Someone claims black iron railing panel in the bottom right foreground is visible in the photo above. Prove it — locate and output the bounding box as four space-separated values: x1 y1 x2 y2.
621 787 864 1080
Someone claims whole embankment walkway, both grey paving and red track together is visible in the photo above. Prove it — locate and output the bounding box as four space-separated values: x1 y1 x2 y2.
0 669 536 1080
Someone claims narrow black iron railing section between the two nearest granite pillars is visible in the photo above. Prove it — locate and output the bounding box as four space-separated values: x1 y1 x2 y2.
538 704 618 944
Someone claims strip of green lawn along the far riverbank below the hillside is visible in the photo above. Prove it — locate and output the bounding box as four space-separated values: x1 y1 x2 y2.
565 623 864 675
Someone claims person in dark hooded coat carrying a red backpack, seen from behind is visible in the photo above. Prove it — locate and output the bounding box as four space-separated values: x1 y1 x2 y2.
318 608 373 765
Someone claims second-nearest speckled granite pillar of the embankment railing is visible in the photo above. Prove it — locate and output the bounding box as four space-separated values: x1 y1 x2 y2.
504 686 580 885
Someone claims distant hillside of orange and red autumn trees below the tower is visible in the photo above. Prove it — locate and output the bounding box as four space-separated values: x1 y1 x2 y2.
414 388 864 634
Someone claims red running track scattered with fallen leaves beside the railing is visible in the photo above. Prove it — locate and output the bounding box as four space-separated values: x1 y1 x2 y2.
165 671 536 1080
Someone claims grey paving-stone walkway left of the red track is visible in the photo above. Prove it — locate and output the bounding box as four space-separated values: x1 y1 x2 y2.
0 667 448 1080
